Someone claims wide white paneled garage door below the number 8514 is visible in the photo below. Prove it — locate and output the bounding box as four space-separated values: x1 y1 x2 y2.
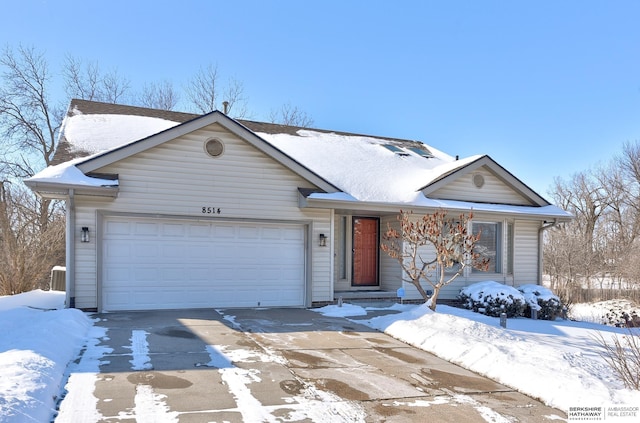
102 217 305 311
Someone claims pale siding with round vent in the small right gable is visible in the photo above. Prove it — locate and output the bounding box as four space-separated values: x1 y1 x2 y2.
429 167 532 206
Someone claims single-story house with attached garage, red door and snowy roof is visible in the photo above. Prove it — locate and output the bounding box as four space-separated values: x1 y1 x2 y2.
25 100 572 311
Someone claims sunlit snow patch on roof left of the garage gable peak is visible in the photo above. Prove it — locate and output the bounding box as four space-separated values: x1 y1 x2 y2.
62 109 179 154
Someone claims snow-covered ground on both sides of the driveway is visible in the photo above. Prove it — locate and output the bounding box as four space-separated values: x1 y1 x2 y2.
0 291 640 422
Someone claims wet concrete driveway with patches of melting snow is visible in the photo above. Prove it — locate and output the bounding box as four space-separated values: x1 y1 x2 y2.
56 309 566 423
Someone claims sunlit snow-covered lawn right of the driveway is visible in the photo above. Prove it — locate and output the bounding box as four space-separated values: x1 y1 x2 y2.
314 305 640 411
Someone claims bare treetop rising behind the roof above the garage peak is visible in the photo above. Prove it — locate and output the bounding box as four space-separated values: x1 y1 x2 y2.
186 65 247 118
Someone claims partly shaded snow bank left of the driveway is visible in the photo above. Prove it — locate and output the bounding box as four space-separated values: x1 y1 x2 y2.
0 290 91 422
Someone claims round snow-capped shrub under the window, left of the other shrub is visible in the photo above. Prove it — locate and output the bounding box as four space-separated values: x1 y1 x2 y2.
458 281 525 317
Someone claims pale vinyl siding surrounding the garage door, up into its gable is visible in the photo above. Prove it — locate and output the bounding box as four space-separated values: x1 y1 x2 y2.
75 124 333 308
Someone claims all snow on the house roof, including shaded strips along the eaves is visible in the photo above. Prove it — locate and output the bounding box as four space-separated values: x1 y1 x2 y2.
28 101 570 217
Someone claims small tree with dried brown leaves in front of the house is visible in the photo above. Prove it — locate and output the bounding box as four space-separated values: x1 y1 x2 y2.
380 210 489 311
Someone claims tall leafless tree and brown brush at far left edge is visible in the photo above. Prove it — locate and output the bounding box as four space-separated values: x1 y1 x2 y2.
0 46 64 294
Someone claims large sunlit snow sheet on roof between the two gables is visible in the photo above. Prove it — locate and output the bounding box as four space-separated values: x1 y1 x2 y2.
257 130 470 203
